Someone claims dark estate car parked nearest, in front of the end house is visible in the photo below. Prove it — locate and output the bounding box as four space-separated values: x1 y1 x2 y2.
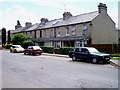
69 47 110 64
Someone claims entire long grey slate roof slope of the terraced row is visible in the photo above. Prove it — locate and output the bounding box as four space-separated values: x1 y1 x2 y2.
12 11 99 33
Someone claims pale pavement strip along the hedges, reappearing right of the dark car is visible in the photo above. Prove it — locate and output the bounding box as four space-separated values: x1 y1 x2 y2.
42 53 120 67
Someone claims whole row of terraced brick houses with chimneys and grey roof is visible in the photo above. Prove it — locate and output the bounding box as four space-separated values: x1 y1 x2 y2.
11 3 118 51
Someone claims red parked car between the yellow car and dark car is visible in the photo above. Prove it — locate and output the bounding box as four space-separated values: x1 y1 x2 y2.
24 46 43 55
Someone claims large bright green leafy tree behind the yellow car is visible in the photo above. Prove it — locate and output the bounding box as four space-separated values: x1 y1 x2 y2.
12 33 29 45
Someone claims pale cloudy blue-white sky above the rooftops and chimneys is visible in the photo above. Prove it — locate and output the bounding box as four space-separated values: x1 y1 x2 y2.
0 0 120 30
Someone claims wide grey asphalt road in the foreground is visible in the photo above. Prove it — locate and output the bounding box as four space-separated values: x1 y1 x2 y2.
2 51 118 88
